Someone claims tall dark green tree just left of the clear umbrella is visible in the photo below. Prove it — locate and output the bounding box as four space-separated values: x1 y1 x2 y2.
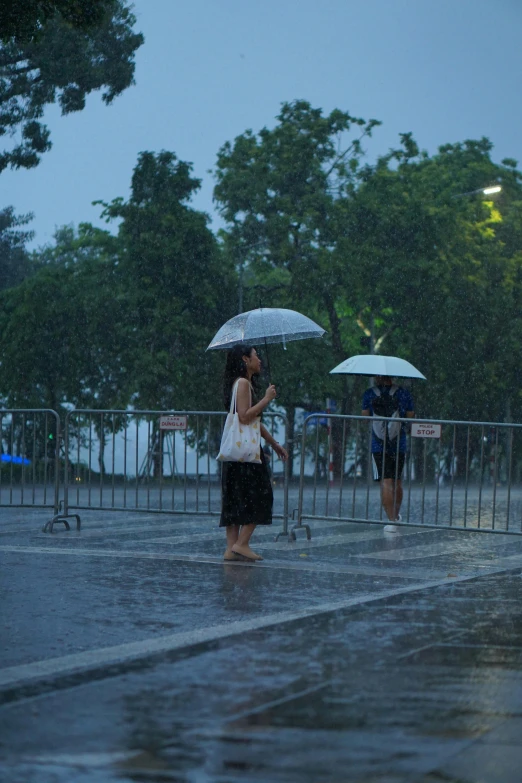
98 152 235 410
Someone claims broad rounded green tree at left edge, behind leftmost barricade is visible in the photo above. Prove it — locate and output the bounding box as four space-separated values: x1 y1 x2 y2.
0 225 128 410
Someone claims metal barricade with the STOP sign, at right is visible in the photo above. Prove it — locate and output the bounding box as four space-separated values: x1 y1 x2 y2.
289 413 522 540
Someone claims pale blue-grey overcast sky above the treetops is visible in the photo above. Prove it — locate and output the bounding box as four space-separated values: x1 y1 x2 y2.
0 0 522 245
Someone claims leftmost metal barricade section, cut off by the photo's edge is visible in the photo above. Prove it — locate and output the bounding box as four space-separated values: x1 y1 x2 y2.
0 408 61 514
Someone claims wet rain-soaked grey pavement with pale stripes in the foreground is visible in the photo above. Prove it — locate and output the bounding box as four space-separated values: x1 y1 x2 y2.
0 509 522 783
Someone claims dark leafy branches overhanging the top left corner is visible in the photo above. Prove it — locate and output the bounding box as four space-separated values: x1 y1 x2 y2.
0 0 143 172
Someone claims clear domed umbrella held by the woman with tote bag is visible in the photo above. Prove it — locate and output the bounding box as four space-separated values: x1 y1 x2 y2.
207 307 325 351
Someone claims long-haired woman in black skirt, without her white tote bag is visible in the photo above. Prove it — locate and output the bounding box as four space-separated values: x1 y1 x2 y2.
219 345 288 560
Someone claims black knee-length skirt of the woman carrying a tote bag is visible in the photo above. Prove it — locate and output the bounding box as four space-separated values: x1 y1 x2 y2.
219 380 274 527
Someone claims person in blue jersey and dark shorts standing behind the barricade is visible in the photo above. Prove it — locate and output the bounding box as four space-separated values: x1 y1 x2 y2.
362 375 415 533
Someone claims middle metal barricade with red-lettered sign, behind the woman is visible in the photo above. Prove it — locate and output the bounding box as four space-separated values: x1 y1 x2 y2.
48 409 288 537
